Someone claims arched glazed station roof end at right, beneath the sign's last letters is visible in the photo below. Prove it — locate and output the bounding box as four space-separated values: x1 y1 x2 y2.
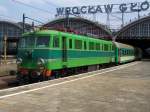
116 16 150 40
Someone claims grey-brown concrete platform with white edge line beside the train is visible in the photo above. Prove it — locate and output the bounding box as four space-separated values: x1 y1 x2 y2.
0 61 150 112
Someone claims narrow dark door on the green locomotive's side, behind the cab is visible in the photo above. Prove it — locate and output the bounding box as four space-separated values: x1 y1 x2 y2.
62 36 67 62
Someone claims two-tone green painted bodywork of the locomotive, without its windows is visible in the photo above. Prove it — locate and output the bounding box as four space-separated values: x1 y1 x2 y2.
18 30 136 70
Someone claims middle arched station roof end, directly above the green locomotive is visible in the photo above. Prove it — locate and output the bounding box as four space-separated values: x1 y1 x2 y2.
43 17 112 39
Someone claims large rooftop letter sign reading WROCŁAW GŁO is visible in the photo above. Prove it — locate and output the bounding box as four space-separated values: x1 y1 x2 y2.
56 1 150 16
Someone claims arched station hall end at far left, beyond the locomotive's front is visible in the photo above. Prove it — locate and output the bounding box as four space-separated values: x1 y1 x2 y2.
0 20 31 55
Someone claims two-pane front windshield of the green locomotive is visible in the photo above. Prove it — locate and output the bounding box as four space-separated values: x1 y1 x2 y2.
19 36 50 48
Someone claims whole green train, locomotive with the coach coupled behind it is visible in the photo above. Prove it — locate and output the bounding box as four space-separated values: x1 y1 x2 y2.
17 30 141 83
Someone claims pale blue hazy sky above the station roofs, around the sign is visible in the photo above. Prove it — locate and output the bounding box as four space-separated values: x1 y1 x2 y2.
0 0 150 28
